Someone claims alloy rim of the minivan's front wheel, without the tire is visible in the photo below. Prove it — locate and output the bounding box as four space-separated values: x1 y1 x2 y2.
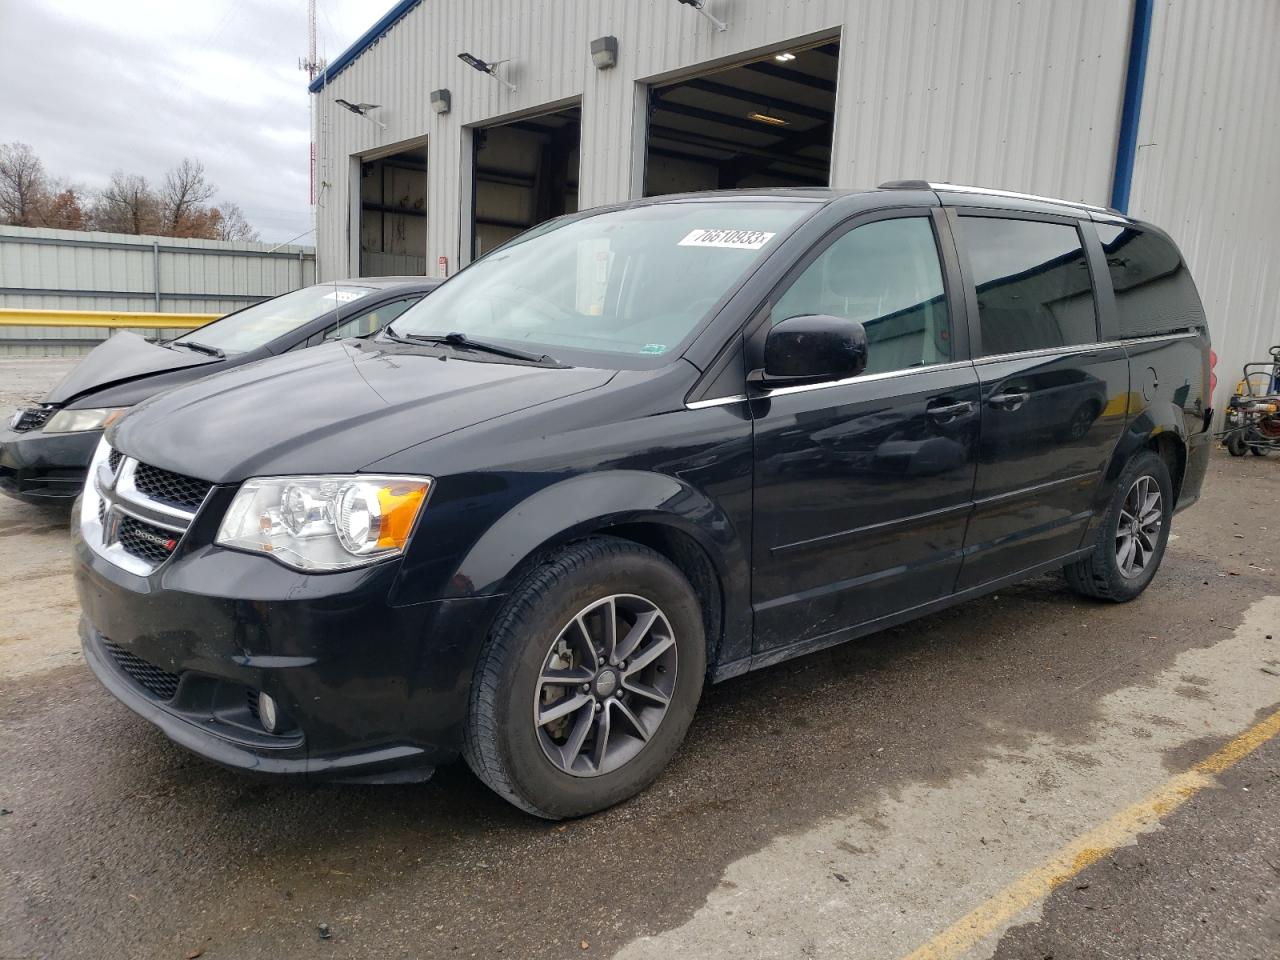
534 594 677 777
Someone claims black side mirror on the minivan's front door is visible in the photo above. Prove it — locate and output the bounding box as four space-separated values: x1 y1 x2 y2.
748 314 867 387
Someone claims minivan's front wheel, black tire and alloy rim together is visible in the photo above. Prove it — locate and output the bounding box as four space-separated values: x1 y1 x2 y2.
463 536 707 819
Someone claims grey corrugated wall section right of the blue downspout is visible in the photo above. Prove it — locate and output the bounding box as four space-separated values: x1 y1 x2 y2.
1130 0 1280 410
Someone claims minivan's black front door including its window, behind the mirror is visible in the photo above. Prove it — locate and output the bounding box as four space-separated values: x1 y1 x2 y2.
751 210 979 653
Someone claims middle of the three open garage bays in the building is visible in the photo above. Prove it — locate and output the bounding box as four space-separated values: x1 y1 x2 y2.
471 105 581 257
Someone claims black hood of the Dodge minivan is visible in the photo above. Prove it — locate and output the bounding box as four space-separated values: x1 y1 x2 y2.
108 340 614 484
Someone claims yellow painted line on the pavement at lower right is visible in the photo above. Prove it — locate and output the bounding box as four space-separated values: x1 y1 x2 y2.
904 710 1280 960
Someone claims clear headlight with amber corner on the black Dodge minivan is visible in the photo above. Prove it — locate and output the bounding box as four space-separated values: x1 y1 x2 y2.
218 475 431 571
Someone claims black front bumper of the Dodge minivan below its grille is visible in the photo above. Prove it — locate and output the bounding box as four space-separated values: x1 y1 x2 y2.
73 522 500 782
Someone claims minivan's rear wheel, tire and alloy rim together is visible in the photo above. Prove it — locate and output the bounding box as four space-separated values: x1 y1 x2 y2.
1062 451 1174 603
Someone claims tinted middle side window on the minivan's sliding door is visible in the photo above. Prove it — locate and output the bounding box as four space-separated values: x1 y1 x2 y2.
959 216 1098 357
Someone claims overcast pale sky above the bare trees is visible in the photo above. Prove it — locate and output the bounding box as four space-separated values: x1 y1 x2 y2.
0 0 376 244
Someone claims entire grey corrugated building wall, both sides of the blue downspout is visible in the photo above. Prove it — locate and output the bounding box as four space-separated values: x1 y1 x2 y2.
316 0 1280 417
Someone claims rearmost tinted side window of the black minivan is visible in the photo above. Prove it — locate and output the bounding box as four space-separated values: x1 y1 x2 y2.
1097 224 1204 337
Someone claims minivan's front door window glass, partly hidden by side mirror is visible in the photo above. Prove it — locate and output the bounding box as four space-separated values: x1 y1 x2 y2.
769 216 951 374
